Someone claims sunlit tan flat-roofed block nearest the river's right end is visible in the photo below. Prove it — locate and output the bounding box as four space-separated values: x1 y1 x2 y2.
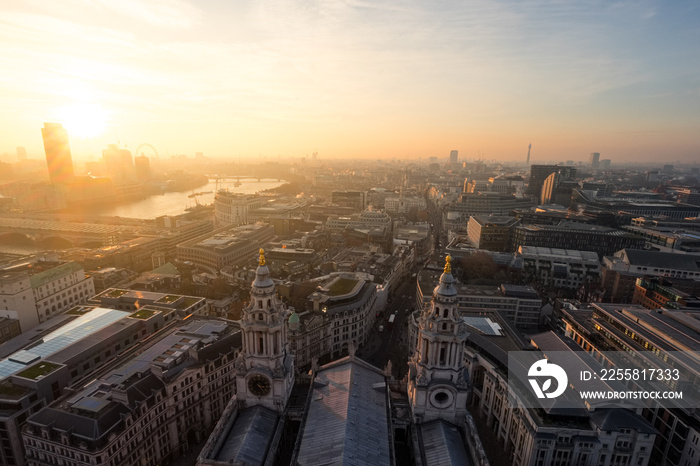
177 223 274 272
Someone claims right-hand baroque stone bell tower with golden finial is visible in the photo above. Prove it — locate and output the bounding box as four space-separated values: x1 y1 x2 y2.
408 256 469 425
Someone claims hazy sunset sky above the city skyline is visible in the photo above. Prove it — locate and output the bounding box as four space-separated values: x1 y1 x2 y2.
0 0 700 164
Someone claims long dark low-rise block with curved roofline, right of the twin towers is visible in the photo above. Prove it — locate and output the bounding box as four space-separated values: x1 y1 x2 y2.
511 222 644 256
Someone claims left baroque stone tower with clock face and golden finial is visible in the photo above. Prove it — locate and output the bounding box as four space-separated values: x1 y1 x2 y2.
236 249 294 413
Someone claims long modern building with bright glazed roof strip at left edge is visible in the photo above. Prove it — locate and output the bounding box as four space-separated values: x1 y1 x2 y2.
0 306 180 465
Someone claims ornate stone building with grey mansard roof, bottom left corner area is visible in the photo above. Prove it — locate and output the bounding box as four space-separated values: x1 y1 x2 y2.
22 321 240 466
